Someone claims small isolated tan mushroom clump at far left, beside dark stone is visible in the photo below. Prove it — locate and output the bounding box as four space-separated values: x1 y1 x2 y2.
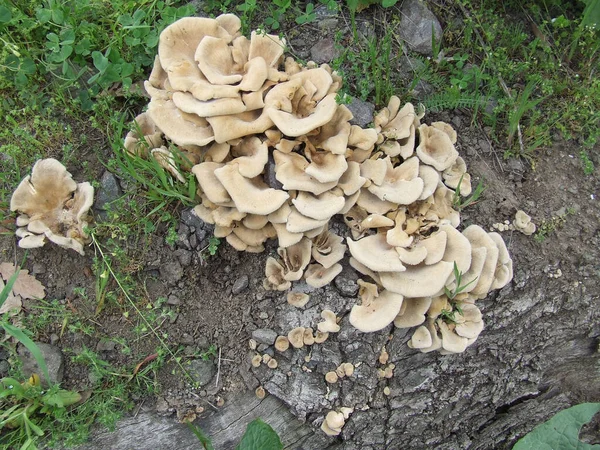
10 158 94 255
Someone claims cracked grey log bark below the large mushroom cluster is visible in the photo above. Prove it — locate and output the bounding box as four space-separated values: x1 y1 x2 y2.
254 137 600 450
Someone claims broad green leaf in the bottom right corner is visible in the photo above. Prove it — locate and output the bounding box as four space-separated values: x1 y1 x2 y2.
513 403 600 450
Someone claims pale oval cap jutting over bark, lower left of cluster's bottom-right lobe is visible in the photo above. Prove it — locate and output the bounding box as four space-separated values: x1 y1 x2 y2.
350 290 404 333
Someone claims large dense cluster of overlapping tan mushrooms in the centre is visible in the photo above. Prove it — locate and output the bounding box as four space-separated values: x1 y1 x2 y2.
125 14 512 352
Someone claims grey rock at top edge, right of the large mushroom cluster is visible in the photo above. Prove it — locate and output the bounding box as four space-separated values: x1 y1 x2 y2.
398 0 442 55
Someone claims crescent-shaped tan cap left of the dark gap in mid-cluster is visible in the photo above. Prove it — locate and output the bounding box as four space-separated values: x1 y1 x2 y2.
214 163 289 215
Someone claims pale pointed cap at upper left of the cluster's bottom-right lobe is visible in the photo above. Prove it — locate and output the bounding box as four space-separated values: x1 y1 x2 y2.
348 233 406 272
